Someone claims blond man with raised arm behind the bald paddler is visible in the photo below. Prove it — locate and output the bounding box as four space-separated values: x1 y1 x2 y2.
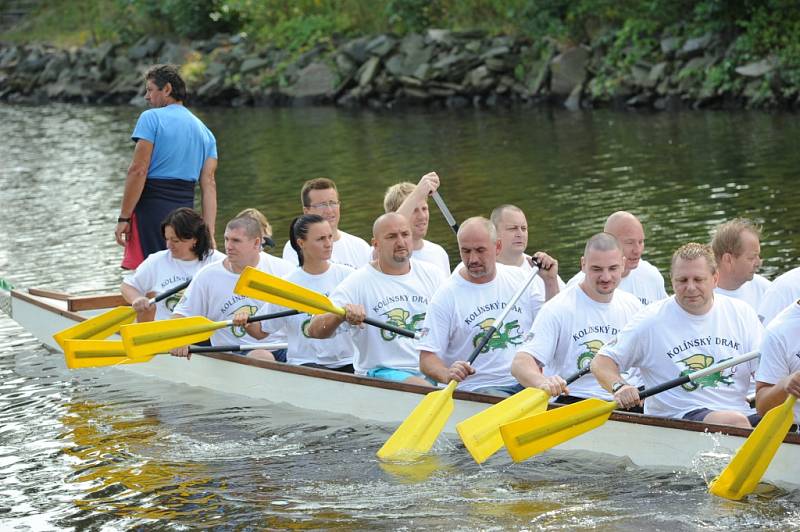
383 172 450 275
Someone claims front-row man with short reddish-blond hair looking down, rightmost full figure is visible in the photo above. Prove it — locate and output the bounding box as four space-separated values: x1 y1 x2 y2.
592 243 763 427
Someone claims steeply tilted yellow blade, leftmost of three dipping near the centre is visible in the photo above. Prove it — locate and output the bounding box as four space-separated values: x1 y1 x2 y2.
377 381 456 462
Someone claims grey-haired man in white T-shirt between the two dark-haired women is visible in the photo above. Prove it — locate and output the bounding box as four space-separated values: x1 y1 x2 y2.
170 216 294 362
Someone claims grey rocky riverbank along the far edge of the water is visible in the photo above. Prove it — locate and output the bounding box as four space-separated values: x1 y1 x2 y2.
0 29 800 110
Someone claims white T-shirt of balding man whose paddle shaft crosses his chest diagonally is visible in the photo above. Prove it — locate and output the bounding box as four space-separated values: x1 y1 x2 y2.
416 264 543 391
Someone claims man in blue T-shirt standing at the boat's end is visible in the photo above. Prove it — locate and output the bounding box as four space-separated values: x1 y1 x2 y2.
114 65 217 270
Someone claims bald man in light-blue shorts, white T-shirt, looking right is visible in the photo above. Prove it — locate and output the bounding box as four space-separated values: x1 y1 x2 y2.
308 213 445 386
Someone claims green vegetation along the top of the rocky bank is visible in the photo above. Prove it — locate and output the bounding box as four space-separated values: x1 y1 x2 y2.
0 0 800 103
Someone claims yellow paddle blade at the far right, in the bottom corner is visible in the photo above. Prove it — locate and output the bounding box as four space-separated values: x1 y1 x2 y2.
708 395 797 501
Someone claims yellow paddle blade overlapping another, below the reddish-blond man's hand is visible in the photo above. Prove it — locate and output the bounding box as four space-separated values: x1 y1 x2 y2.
500 399 617 462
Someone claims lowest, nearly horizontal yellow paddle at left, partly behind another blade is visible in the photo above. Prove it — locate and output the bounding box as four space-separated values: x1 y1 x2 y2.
64 340 287 369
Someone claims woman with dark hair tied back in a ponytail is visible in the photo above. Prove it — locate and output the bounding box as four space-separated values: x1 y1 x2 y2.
234 214 356 373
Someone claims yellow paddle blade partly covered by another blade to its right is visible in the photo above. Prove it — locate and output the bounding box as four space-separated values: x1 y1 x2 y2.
456 388 550 464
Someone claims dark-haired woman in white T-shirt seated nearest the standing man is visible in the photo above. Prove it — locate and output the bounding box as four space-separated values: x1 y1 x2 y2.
121 207 225 321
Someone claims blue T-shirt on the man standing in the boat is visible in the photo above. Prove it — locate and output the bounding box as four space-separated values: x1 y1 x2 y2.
131 104 217 181
